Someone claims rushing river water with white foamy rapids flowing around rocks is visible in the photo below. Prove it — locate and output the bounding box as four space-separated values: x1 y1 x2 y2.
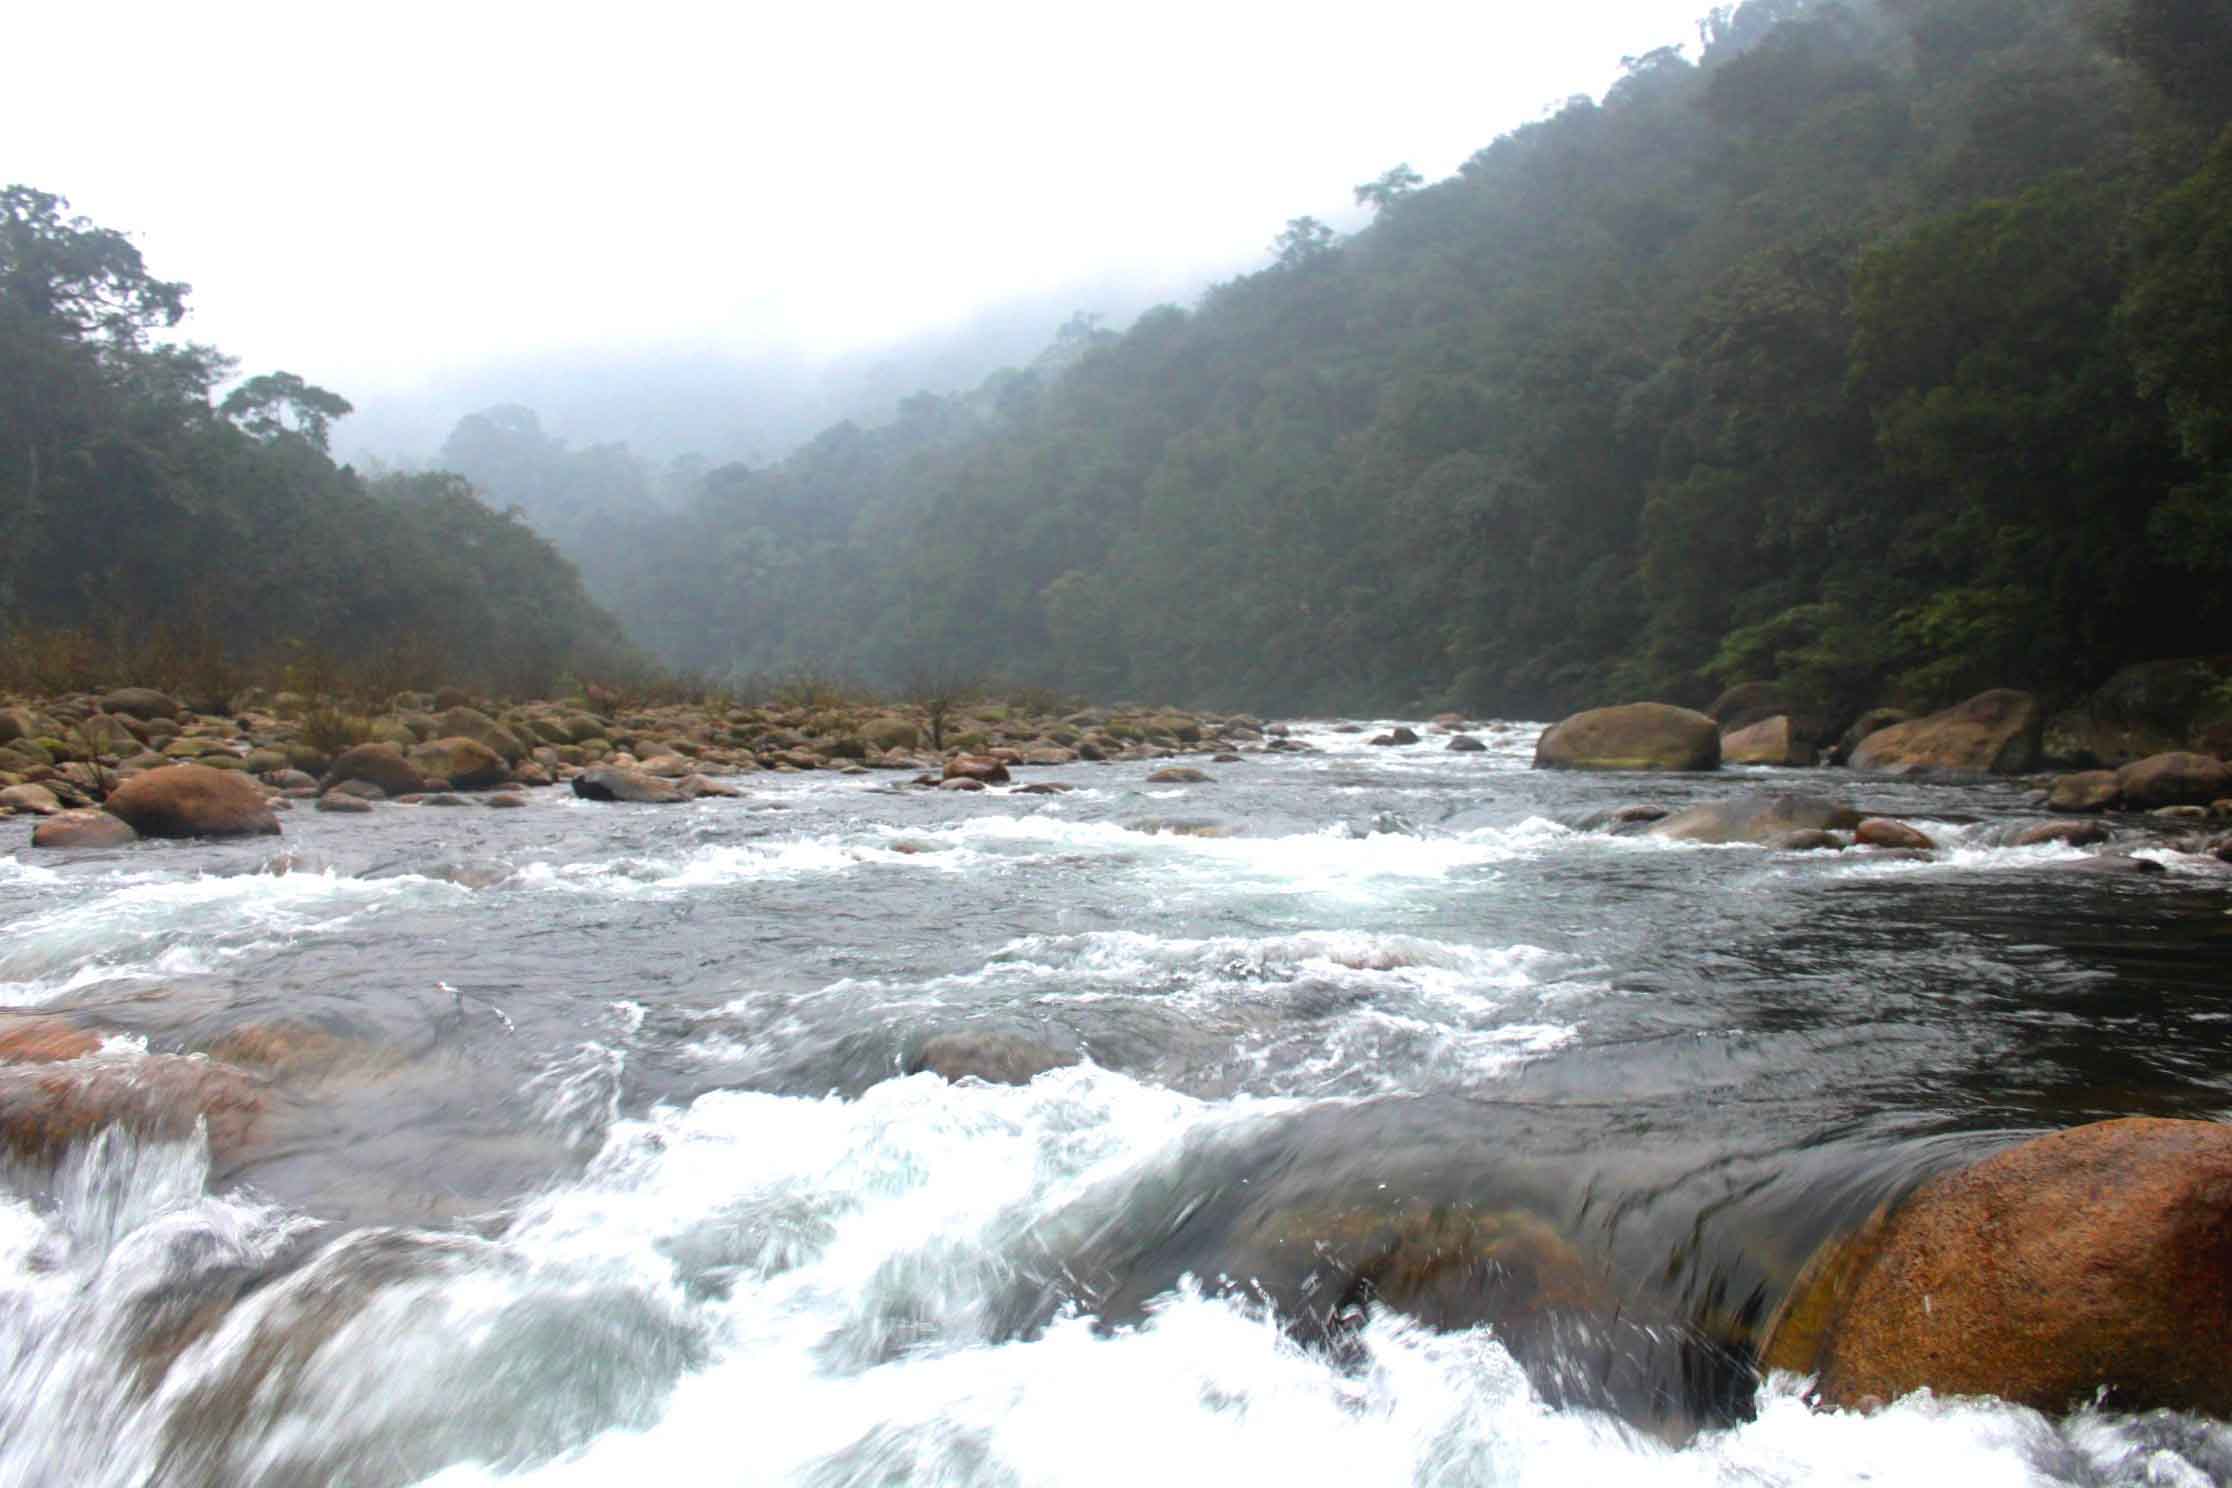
0 727 2232 1488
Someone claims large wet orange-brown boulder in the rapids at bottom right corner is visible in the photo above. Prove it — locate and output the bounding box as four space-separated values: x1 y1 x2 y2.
1763 1120 2232 1417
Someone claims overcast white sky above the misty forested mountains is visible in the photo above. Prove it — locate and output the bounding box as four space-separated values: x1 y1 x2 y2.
0 0 1710 402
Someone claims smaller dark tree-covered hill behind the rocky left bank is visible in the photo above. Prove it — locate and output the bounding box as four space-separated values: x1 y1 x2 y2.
0 185 638 692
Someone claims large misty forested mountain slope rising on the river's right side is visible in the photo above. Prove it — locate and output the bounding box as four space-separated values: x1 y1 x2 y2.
605 0 2232 714
